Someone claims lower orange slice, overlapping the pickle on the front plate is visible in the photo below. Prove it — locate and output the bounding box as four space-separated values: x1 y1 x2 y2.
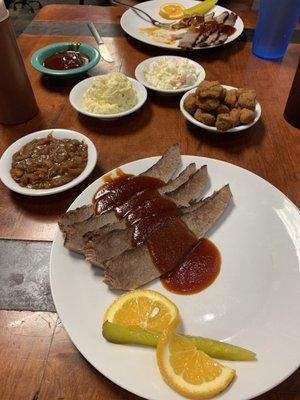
156 324 235 399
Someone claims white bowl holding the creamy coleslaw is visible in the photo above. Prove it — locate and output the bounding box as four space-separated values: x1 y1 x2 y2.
135 56 206 95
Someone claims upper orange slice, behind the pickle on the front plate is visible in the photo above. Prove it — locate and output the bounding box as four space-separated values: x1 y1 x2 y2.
104 290 179 332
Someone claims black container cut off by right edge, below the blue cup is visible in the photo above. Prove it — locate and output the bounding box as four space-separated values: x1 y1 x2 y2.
284 61 300 128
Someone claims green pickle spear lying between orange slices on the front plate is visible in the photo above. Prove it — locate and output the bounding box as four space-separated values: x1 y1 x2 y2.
102 321 256 361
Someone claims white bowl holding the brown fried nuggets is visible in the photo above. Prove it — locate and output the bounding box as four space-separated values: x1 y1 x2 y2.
180 85 261 133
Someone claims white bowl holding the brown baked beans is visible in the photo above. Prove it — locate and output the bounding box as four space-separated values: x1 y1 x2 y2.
0 129 97 196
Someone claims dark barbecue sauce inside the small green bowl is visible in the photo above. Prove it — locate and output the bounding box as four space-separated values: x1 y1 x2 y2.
44 50 90 70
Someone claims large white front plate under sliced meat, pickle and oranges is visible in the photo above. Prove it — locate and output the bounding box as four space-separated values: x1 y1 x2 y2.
50 156 300 400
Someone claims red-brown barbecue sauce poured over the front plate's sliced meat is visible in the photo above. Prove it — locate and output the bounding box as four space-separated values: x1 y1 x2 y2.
94 170 221 294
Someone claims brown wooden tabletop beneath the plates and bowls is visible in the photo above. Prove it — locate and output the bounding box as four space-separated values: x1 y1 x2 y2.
0 1 300 400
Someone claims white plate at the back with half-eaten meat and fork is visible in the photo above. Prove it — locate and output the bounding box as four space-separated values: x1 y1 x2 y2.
120 0 244 51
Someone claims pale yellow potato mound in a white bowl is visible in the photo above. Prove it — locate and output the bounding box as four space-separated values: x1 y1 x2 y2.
83 72 137 114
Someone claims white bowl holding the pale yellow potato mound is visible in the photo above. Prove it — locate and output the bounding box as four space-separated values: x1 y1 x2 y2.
69 76 147 120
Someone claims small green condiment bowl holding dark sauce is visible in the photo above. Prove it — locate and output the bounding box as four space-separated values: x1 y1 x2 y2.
31 42 100 78
